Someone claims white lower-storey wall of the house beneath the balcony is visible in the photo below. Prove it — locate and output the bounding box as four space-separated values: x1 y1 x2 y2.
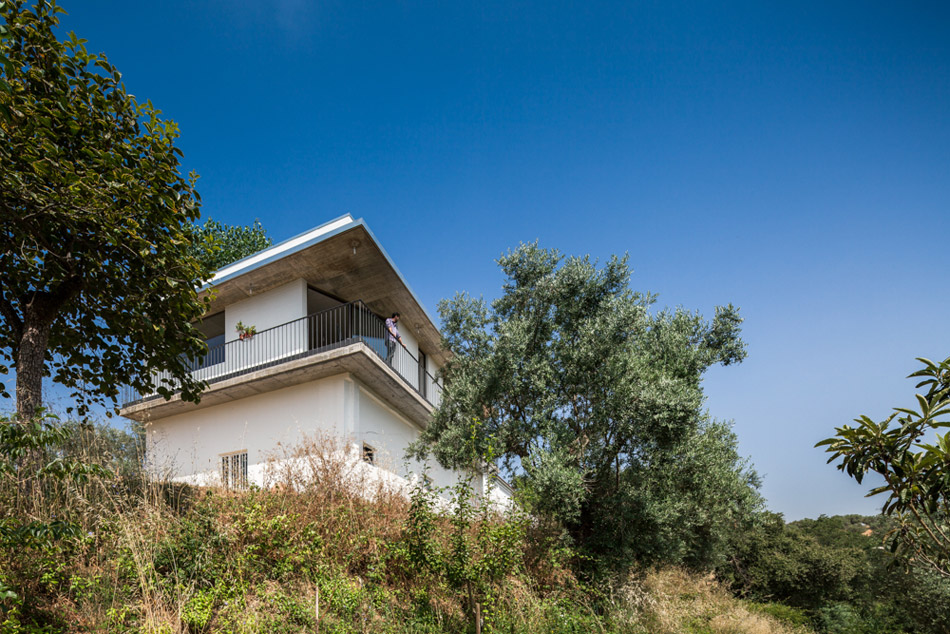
146 374 510 504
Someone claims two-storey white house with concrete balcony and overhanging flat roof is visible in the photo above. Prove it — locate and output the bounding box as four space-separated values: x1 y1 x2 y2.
120 215 510 498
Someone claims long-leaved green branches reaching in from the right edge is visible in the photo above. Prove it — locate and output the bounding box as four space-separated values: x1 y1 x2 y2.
816 358 950 577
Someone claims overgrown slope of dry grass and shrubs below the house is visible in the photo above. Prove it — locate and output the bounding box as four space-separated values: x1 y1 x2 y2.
0 426 809 634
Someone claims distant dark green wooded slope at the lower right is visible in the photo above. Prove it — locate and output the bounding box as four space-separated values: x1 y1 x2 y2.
717 513 950 634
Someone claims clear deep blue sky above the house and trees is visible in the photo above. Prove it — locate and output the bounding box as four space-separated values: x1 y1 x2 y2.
41 0 950 519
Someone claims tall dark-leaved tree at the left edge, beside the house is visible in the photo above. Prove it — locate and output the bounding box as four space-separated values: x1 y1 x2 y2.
0 0 210 420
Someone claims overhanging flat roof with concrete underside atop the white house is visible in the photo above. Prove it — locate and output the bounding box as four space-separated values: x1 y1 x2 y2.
202 216 446 365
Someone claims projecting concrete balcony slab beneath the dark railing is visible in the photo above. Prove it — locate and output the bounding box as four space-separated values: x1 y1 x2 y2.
119 342 433 428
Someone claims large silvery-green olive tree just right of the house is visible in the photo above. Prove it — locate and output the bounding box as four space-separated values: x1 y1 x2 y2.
413 244 745 564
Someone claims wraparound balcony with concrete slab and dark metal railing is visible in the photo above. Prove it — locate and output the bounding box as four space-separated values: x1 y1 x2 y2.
121 301 442 420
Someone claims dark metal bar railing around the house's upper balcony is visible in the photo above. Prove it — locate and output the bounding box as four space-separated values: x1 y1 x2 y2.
121 301 442 407
